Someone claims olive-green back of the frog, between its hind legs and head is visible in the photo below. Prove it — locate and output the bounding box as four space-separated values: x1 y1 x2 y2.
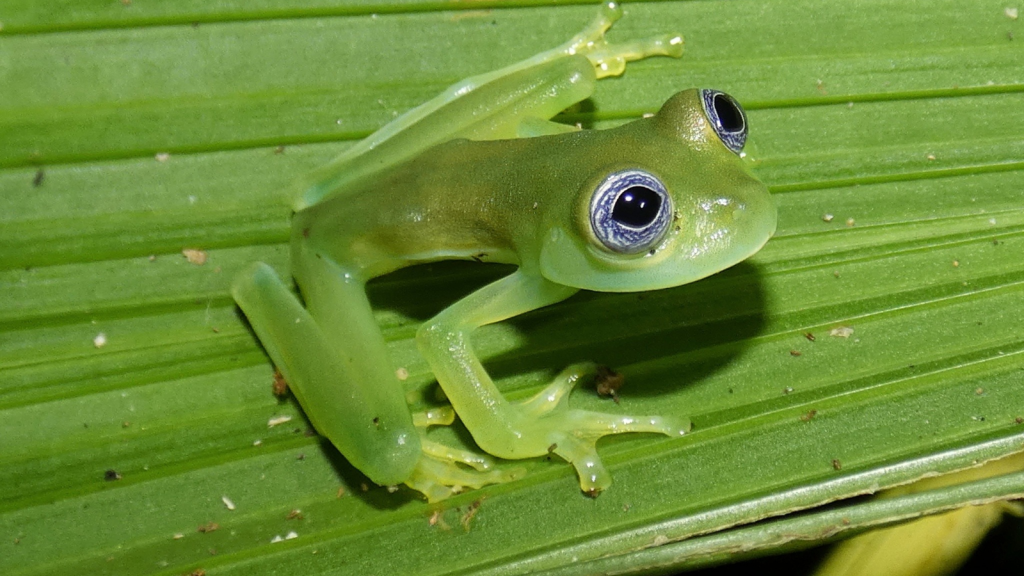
294 135 548 277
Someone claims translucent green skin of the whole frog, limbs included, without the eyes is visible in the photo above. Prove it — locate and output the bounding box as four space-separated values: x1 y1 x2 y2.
232 4 776 500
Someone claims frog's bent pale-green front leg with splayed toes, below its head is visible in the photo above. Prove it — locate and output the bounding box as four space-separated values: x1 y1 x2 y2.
417 271 689 494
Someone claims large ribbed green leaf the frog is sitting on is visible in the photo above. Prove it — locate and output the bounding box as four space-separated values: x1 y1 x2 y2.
0 0 1024 575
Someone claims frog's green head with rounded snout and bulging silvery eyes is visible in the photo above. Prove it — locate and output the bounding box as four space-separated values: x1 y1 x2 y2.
540 89 776 292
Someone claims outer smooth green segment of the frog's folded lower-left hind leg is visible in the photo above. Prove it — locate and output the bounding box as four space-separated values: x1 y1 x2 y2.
231 262 420 485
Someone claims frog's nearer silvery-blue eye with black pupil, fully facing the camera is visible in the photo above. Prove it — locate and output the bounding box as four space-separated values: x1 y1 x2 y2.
590 170 672 254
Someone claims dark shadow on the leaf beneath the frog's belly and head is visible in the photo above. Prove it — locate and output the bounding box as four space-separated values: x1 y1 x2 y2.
371 258 766 396
